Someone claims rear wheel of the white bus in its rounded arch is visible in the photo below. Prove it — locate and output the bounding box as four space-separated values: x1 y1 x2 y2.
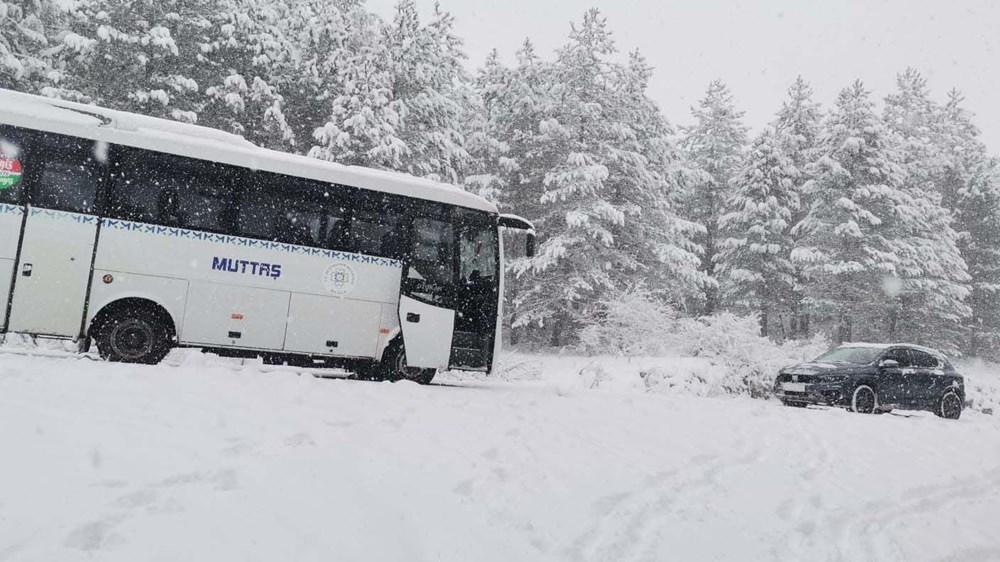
94 307 173 365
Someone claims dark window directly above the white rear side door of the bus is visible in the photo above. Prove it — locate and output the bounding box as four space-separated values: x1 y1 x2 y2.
32 133 108 214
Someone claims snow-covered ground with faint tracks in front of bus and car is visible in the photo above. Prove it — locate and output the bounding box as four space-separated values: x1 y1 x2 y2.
0 348 1000 562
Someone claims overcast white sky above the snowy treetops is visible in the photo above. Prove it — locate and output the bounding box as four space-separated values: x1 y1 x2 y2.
368 0 1000 153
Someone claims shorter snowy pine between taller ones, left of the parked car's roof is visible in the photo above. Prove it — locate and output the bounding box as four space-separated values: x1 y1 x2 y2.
719 130 799 337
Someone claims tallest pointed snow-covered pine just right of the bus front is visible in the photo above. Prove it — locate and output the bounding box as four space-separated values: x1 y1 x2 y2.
514 9 634 346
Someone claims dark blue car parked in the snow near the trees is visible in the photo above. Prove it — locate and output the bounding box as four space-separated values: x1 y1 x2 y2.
774 344 965 420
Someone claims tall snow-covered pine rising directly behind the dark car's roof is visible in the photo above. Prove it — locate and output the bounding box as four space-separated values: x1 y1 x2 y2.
792 81 905 341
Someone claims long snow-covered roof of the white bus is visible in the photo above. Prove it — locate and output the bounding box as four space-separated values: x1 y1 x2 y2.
0 88 498 213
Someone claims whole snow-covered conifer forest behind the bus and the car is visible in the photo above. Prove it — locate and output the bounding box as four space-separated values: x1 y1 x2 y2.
0 0 1000 356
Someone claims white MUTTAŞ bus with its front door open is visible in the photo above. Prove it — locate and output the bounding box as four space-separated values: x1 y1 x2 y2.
0 90 534 383
